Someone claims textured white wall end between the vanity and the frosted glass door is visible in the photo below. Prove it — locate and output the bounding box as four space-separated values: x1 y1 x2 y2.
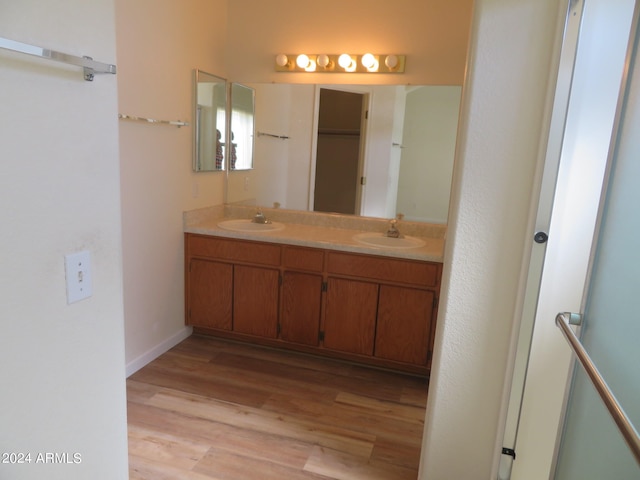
419 0 562 480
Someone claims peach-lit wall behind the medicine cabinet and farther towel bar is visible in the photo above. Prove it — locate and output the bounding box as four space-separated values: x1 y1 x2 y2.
115 0 226 374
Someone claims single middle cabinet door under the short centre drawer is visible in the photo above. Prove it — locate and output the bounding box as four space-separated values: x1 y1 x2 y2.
280 272 322 346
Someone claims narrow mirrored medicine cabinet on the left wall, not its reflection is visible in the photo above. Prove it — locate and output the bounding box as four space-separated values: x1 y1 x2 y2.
193 70 227 172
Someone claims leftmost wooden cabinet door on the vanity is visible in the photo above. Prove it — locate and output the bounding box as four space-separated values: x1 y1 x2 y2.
187 259 233 330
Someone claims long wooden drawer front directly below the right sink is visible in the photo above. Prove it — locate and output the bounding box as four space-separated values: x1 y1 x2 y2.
327 252 441 287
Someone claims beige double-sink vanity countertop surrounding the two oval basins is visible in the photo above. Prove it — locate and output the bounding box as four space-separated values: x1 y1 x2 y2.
184 212 444 263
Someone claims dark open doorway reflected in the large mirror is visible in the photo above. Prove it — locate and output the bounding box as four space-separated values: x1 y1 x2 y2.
313 88 368 214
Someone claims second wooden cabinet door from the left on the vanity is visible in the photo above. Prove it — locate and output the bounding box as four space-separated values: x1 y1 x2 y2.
233 265 280 338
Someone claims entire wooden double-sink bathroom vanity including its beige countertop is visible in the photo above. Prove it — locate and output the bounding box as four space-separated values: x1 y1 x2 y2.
185 204 444 375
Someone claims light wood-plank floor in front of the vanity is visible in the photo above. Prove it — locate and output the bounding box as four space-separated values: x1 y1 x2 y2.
127 335 427 480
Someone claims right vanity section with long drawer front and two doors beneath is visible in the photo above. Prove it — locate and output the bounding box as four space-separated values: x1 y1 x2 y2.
324 252 442 368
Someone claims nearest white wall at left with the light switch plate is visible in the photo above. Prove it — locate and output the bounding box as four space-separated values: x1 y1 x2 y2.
0 0 128 480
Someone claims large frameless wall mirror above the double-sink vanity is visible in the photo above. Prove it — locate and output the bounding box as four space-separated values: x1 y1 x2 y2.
226 84 462 224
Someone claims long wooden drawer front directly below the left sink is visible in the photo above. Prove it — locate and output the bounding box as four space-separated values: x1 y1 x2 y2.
187 234 280 266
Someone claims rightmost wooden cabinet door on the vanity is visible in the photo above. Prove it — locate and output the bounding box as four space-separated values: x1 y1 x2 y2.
375 285 434 365
